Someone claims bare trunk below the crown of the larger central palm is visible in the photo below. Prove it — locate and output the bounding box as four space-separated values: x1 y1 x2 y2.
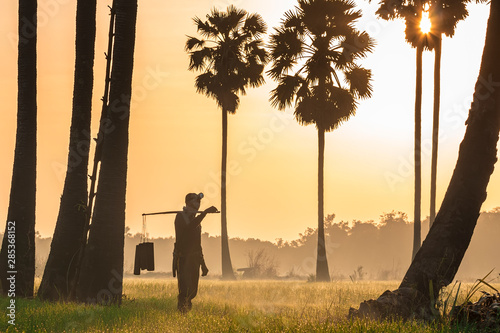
316 126 330 281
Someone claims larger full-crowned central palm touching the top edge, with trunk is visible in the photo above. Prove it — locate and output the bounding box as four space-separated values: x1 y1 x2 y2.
268 0 374 281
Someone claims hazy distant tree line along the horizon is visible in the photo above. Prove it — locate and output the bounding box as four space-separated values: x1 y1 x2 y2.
26 207 500 280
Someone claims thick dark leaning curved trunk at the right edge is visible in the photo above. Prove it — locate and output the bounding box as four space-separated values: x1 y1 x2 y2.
351 0 500 318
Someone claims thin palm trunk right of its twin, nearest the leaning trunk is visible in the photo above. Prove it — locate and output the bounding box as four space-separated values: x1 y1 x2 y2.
429 34 442 228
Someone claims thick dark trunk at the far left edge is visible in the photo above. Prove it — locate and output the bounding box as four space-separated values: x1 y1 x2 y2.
0 0 37 297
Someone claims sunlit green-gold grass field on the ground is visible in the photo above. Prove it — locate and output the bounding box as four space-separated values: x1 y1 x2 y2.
0 279 496 332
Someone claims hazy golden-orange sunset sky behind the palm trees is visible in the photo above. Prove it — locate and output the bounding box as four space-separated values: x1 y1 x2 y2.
0 0 494 241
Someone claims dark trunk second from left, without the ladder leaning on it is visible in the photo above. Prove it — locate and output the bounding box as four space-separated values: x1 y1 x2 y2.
38 0 96 300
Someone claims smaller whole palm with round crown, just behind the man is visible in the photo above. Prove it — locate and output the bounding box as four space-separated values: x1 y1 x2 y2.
186 5 267 279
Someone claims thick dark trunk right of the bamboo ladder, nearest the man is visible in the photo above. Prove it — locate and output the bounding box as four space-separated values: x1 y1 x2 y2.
77 0 137 304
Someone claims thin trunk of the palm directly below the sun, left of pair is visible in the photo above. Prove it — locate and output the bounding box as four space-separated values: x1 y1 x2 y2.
412 46 424 259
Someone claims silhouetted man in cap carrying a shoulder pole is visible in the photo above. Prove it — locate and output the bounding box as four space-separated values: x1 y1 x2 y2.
172 193 217 313
